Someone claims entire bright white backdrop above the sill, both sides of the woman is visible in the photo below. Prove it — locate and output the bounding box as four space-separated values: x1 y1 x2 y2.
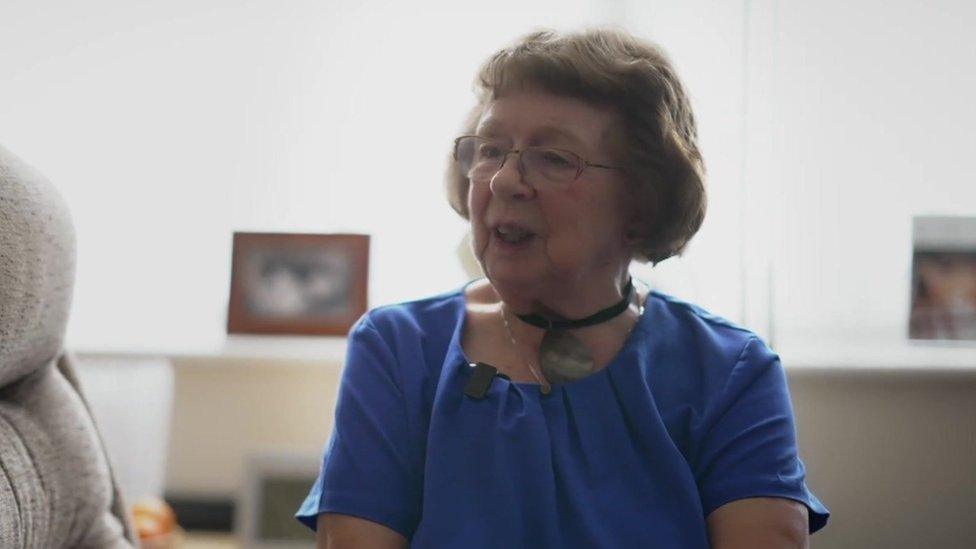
0 0 976 353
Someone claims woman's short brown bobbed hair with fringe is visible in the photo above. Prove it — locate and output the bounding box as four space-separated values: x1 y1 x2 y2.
447 28 706 264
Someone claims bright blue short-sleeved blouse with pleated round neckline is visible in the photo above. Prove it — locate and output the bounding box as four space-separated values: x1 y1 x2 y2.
296 280 829 549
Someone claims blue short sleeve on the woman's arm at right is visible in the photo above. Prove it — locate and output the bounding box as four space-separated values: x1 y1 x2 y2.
695 337 829 533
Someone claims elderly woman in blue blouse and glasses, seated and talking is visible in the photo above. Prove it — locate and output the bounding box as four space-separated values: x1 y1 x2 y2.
298 26 828 549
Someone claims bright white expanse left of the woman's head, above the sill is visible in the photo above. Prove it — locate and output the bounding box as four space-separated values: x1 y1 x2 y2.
0 0 632 352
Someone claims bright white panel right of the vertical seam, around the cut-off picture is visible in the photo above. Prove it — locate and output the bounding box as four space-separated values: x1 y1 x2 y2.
747 0 976 346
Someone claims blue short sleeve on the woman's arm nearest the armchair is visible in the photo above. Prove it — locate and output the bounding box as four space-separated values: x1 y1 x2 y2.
295 316 422 539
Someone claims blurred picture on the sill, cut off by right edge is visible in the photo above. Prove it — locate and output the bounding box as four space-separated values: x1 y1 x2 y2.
908 217 976 341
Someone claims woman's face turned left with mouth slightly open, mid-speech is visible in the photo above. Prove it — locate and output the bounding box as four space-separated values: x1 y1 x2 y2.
468 91 632 291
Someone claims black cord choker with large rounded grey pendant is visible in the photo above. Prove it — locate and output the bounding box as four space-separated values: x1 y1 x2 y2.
516 279 639 386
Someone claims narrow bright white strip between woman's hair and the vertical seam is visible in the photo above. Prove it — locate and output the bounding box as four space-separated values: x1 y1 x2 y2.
624 0 752 332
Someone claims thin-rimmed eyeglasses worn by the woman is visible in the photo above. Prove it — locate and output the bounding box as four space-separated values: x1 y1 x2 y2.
454 135 623 183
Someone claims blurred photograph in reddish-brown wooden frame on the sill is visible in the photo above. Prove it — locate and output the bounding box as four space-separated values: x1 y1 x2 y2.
227 232 369 335
